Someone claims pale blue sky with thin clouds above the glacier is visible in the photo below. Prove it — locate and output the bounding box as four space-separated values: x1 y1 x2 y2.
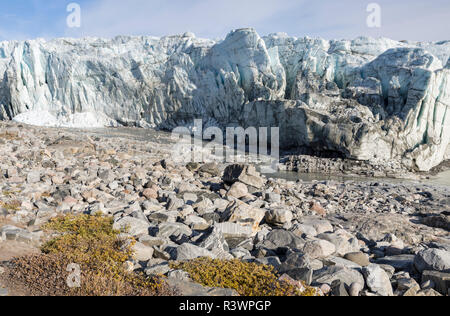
0 0 450 41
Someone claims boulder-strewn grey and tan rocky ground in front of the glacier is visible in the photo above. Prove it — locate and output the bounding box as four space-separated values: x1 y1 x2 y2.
0 122 450 296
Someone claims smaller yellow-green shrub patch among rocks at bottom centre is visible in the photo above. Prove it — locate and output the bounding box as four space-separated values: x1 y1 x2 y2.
171 258 317 296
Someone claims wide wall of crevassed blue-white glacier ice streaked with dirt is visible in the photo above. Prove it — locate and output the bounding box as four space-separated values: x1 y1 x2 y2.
0 28 450 171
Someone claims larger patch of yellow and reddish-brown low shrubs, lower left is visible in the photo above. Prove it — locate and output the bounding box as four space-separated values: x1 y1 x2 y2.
5 215 176 296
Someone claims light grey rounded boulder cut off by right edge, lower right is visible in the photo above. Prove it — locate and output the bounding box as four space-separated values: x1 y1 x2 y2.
414 249 450 272
